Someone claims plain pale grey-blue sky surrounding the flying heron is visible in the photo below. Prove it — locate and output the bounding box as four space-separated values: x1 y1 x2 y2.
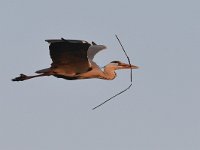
0 0 200 150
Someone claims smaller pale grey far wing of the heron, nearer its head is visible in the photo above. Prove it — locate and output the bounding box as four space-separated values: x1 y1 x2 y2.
87 45 106 60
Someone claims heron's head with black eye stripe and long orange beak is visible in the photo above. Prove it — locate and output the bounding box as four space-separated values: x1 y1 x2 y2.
106 61 138 70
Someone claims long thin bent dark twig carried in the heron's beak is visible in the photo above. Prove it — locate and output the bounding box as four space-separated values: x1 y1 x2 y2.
92 35 133 110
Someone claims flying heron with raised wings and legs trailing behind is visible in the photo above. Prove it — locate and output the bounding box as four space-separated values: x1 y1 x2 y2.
12 38 138 81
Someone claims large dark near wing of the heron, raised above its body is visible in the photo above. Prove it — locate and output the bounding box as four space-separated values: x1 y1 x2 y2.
46 39 91 74
